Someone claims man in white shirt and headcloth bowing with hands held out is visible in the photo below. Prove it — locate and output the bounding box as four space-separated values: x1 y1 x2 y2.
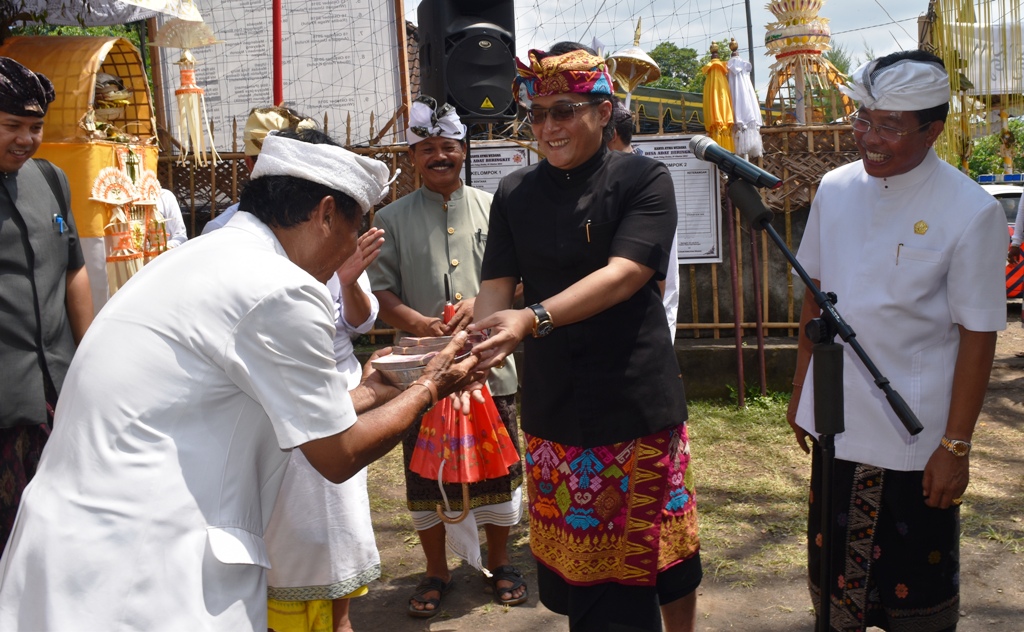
0 130 475 632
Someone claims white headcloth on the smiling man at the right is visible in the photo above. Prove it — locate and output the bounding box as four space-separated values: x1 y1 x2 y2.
839 59 949 112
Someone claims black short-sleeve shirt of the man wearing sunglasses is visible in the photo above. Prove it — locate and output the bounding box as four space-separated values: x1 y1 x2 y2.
482 149 686 447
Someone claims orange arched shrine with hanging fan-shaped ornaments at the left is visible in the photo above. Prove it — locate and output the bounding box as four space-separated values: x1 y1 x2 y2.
0 36 167 295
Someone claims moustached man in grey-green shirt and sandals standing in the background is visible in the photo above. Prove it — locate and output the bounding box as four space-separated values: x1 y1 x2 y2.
368 95 527 619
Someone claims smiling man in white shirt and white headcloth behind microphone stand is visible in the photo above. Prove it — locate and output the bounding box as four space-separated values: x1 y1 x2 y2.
787 50 1007 631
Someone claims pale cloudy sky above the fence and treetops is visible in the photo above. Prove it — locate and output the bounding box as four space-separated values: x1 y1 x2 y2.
404 0 928 98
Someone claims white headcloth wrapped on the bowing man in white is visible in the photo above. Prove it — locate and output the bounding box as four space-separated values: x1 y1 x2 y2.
249 133 398 213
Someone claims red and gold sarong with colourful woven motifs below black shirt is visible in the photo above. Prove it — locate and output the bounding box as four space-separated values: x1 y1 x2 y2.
526 424 699 587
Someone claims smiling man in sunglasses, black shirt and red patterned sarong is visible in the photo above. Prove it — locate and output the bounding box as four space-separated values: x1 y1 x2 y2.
473 42 701 632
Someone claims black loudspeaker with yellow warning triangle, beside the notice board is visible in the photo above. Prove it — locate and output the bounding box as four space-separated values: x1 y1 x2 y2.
417 0 516 124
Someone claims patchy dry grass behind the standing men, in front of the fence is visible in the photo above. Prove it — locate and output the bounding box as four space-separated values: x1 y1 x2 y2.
370 393 1024 587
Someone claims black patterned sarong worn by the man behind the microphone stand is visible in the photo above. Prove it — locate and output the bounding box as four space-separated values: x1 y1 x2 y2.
807 451 959 632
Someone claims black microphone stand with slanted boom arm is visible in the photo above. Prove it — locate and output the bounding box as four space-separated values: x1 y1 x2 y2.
728 176 925 632
